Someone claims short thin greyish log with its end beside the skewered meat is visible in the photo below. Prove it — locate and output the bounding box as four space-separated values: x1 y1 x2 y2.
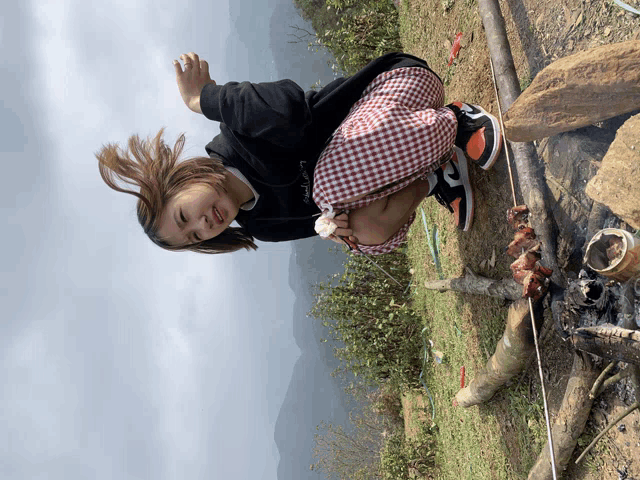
424 270 522 301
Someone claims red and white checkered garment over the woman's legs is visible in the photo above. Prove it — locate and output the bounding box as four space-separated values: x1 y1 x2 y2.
313 67 458 255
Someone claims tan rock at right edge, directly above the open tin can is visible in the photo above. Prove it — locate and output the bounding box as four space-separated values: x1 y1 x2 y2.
585 114 640 228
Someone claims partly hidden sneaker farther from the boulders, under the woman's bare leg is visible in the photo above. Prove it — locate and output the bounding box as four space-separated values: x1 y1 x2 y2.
428 146 473 232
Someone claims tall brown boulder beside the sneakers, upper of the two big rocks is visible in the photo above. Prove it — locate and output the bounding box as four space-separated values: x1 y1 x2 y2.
504 40 640 142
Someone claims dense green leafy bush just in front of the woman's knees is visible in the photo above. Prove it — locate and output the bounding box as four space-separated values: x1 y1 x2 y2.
310 251 422 385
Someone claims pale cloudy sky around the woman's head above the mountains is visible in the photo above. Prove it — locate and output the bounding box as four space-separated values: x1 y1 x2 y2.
0 0 338 480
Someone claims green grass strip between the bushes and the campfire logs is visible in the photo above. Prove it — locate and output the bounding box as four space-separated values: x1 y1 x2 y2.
400 196 546 480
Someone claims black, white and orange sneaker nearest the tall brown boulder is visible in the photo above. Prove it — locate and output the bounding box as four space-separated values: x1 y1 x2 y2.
447 102 502 170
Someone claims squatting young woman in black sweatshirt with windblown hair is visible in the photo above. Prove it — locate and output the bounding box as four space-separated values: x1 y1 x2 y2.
96 52 502 254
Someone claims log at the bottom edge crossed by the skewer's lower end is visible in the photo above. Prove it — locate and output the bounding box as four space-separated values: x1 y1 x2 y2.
527 353 599 480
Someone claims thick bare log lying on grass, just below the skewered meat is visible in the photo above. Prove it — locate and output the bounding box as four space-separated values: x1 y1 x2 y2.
454 298 535 407
